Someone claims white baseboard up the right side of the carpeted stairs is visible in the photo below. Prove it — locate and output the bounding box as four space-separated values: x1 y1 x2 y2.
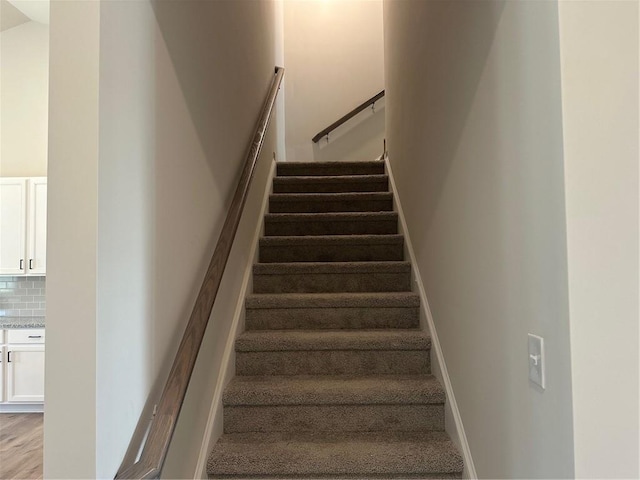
384 157 478 479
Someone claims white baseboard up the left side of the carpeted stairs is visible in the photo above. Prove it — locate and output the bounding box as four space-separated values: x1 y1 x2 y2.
195 160 276 479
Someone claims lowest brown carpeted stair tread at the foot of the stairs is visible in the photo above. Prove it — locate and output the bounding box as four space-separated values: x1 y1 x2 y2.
207 432 463 478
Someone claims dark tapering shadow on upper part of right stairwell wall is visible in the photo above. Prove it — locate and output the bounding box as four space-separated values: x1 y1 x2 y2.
388 1 506 238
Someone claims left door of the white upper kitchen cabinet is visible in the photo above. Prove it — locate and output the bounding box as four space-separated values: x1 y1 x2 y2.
0 178 28 275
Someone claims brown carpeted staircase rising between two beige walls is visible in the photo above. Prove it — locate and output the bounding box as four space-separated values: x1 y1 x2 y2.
207 162 463 479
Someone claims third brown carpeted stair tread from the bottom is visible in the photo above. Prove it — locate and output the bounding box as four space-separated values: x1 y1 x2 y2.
236 329 431 352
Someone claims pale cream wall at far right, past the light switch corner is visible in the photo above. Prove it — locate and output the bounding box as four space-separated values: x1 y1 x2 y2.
560 1 640 478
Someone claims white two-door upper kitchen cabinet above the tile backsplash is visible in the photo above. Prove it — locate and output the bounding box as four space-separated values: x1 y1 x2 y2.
0 177 47 275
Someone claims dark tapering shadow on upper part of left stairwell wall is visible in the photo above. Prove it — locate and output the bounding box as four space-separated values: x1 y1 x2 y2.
151 0 275 198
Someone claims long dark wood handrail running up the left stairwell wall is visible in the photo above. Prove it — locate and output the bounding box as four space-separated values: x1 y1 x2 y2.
115 67 284 479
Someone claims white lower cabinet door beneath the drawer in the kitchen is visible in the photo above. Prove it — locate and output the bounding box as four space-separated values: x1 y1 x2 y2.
6 345 44 403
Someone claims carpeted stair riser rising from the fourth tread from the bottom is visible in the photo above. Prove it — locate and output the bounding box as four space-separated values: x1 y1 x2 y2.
253 272 411 293
